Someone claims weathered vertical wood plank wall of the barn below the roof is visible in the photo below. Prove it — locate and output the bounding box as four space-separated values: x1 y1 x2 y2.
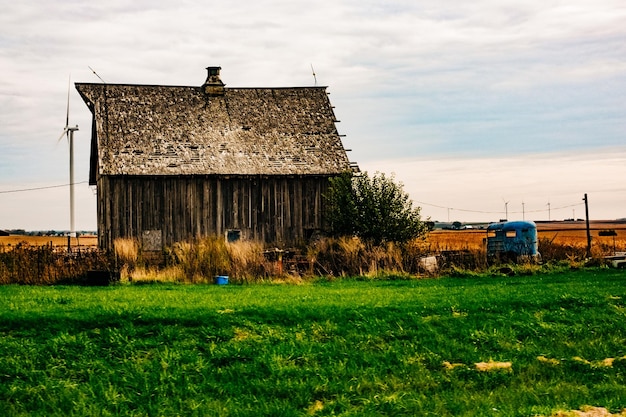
98 176 328 249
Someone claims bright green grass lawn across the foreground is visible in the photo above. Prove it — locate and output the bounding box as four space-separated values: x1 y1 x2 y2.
0 269 626 416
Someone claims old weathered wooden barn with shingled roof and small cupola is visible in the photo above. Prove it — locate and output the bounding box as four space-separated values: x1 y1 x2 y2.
76 67 351 250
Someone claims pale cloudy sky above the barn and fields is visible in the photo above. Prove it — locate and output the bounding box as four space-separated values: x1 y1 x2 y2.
0 0 626 230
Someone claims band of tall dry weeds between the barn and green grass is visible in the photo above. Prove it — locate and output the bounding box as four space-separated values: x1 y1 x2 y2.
0 231 626 284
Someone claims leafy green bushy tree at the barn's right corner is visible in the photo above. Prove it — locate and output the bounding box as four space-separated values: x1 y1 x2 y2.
326 172 427 243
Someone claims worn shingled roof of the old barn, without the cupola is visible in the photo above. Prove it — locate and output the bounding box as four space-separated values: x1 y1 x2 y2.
76 70 350 182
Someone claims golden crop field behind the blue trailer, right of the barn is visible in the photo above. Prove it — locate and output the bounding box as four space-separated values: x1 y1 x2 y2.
428 221 626 255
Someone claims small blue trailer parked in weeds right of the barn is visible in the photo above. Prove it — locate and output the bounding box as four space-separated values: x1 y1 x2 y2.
487 220 540 262
